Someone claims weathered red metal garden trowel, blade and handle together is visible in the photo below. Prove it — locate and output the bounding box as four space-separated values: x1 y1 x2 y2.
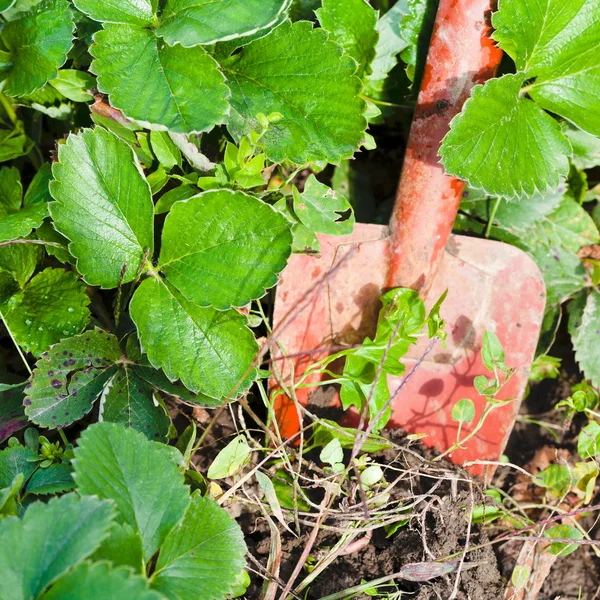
273 0 545 474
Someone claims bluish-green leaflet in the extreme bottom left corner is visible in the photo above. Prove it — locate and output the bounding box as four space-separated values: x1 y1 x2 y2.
0 494 114 600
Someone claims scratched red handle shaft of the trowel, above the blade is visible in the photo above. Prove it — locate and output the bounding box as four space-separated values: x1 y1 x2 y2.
388 0 502 295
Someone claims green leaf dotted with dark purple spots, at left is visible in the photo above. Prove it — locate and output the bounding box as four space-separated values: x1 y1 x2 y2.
24 329 121 428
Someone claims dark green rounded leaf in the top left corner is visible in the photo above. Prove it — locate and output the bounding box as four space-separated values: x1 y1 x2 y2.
1 0 74 97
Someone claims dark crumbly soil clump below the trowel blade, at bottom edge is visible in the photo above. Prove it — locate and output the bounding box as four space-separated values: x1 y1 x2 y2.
240 424 504 600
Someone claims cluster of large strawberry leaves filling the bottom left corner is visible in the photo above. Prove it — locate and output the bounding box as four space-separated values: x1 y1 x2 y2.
0 423 246 600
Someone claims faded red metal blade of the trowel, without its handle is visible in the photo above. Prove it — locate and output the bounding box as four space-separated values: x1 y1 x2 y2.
274 225 545 474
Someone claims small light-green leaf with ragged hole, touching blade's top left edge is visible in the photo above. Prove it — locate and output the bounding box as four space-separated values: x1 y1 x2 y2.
293 175 354 235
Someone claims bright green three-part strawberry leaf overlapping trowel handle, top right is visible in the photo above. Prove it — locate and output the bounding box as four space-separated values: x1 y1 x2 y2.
440 0 600 198
